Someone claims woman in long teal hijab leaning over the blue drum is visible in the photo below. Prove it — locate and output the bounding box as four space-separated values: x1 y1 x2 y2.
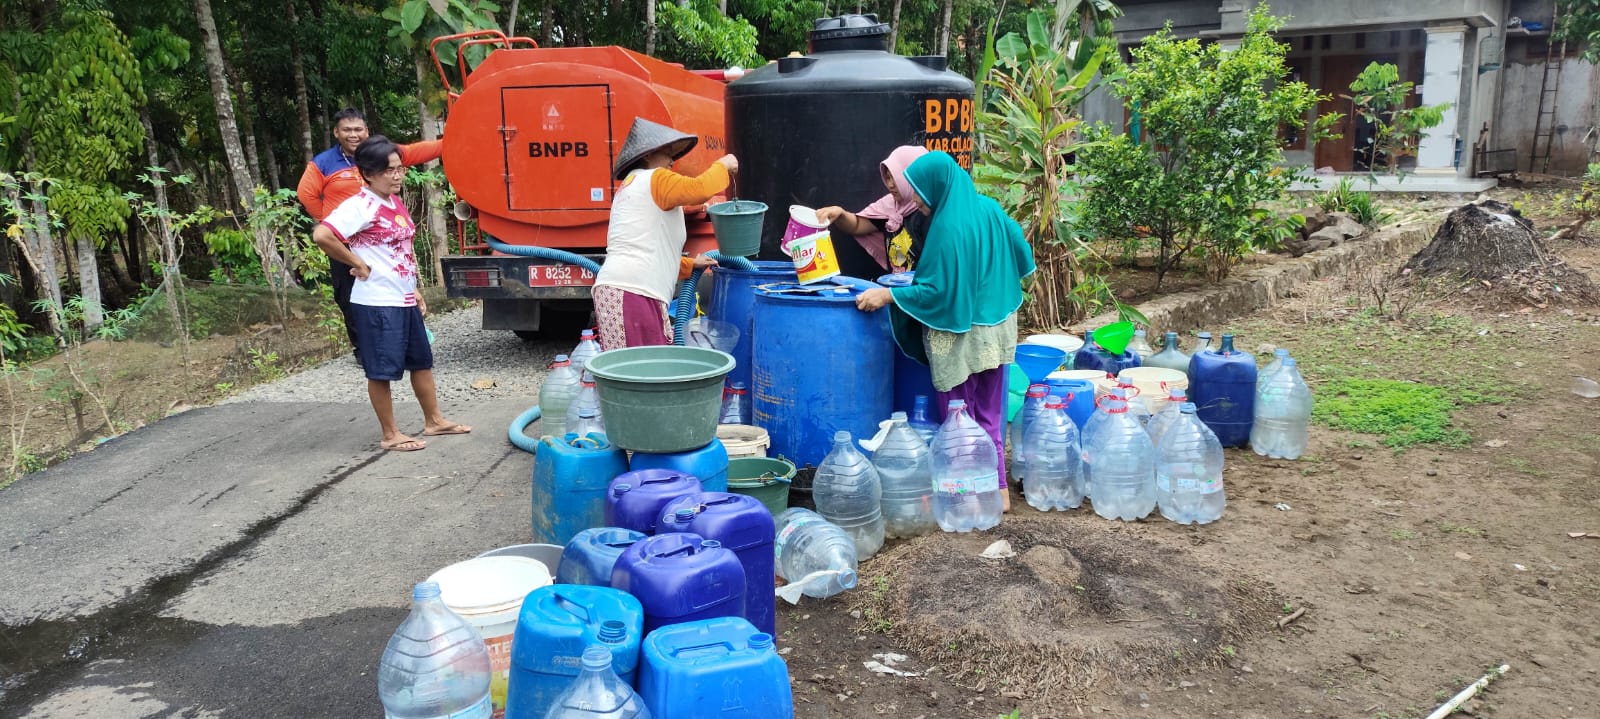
856 152 1034 509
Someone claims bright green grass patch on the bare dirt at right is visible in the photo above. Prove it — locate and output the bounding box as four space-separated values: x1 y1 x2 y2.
1312 378 1499 450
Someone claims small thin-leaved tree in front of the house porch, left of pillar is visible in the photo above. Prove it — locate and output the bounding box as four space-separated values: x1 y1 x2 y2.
1344 62 1450 173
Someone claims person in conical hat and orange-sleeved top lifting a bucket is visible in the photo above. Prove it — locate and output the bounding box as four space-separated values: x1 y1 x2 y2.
592 117 739 349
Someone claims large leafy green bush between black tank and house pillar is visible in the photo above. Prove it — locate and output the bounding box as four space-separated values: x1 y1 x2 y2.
1077 6 1336 283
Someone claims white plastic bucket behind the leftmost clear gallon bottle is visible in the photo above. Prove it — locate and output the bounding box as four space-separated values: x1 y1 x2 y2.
427 556 550 719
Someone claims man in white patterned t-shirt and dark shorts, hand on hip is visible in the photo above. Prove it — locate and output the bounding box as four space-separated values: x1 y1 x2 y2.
312 135 472 452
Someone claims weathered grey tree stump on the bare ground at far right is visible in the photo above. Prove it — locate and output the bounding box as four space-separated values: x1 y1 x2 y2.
1405 200 1600 306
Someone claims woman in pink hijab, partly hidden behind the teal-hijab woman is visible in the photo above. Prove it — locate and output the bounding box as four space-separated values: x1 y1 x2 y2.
816 144 928 272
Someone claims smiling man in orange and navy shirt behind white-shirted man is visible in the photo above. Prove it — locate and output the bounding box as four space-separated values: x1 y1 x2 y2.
296 107 445 357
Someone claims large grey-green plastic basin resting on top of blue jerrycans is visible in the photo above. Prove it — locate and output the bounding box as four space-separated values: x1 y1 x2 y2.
587 346 733 453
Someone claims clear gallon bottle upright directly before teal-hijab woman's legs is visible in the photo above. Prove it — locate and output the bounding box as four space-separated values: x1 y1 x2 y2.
933 399 1003 532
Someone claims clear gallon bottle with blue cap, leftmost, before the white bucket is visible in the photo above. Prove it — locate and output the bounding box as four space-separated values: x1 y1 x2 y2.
378 581 493 719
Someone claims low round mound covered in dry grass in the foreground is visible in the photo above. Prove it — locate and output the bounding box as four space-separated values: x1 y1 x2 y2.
853 517 1282 700
